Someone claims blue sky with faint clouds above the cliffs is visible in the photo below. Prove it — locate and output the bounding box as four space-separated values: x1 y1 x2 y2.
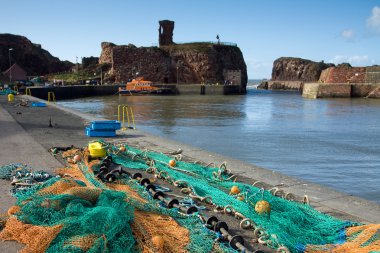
0 0 380 79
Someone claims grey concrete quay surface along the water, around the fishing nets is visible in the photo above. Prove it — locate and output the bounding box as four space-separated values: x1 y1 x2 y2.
0 96 380 252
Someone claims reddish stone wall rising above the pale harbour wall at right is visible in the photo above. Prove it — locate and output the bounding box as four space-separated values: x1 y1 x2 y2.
319 66 366 83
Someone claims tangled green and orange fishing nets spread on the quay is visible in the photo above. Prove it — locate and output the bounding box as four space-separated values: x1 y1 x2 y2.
0 140 380 253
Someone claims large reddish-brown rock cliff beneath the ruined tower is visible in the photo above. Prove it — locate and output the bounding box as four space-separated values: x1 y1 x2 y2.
99 43 248 91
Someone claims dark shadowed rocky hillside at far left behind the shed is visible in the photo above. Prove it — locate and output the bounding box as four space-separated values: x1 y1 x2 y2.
0 34 74 75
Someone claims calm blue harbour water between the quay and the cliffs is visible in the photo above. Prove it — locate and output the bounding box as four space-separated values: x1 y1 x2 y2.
59 84 380 203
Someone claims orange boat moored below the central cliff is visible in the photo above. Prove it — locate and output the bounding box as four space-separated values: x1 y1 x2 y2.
119 77 170 96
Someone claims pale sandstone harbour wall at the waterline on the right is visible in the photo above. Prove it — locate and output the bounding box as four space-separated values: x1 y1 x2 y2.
302 83 380 98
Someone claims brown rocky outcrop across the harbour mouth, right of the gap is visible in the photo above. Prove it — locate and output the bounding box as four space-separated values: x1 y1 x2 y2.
272 57 334 82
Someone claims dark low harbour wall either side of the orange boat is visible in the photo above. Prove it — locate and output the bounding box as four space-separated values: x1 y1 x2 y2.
24 84 243 100
